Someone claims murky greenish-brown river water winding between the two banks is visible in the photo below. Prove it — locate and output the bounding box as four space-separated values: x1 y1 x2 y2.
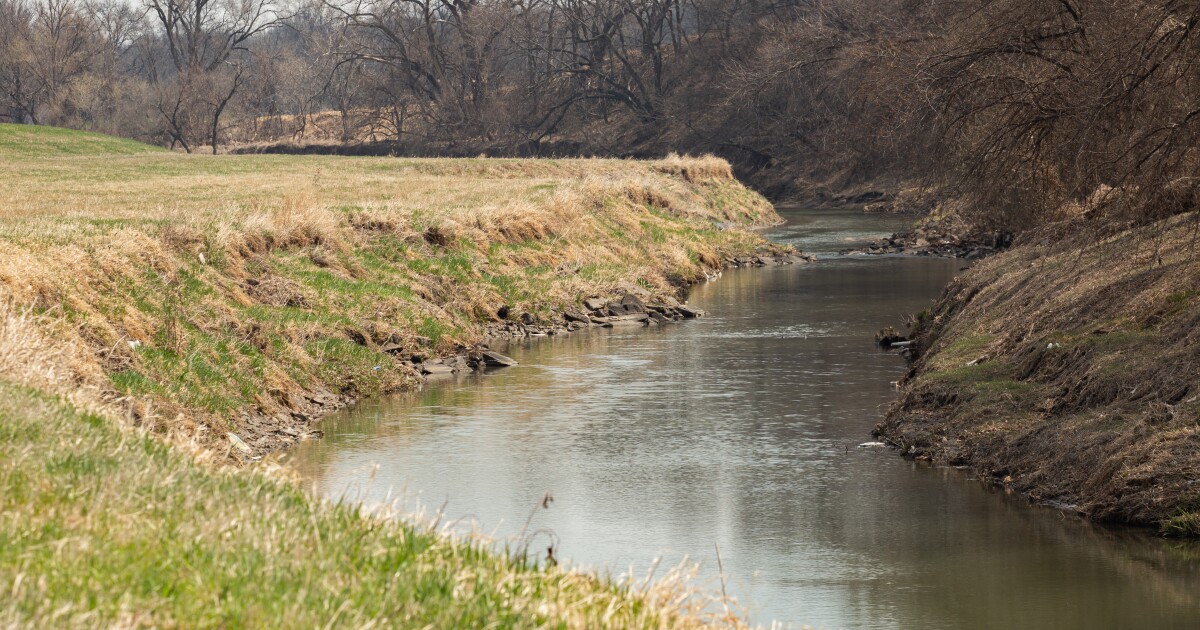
283 211 1200 629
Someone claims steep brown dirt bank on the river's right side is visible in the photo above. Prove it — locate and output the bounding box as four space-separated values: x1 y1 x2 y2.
877 214 1200 535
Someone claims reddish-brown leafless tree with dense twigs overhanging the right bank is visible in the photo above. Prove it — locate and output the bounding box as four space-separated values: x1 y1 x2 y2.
920 0 1200 223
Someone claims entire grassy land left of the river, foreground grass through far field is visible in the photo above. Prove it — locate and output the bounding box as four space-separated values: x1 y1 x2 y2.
0 126 775 628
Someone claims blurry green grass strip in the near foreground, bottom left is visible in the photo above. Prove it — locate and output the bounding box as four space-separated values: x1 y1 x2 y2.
0 383 710 628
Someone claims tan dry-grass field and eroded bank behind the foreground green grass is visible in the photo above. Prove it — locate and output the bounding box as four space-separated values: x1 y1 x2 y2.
0 126 779 455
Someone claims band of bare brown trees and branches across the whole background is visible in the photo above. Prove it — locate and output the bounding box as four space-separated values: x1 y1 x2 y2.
0 0 1200 226
